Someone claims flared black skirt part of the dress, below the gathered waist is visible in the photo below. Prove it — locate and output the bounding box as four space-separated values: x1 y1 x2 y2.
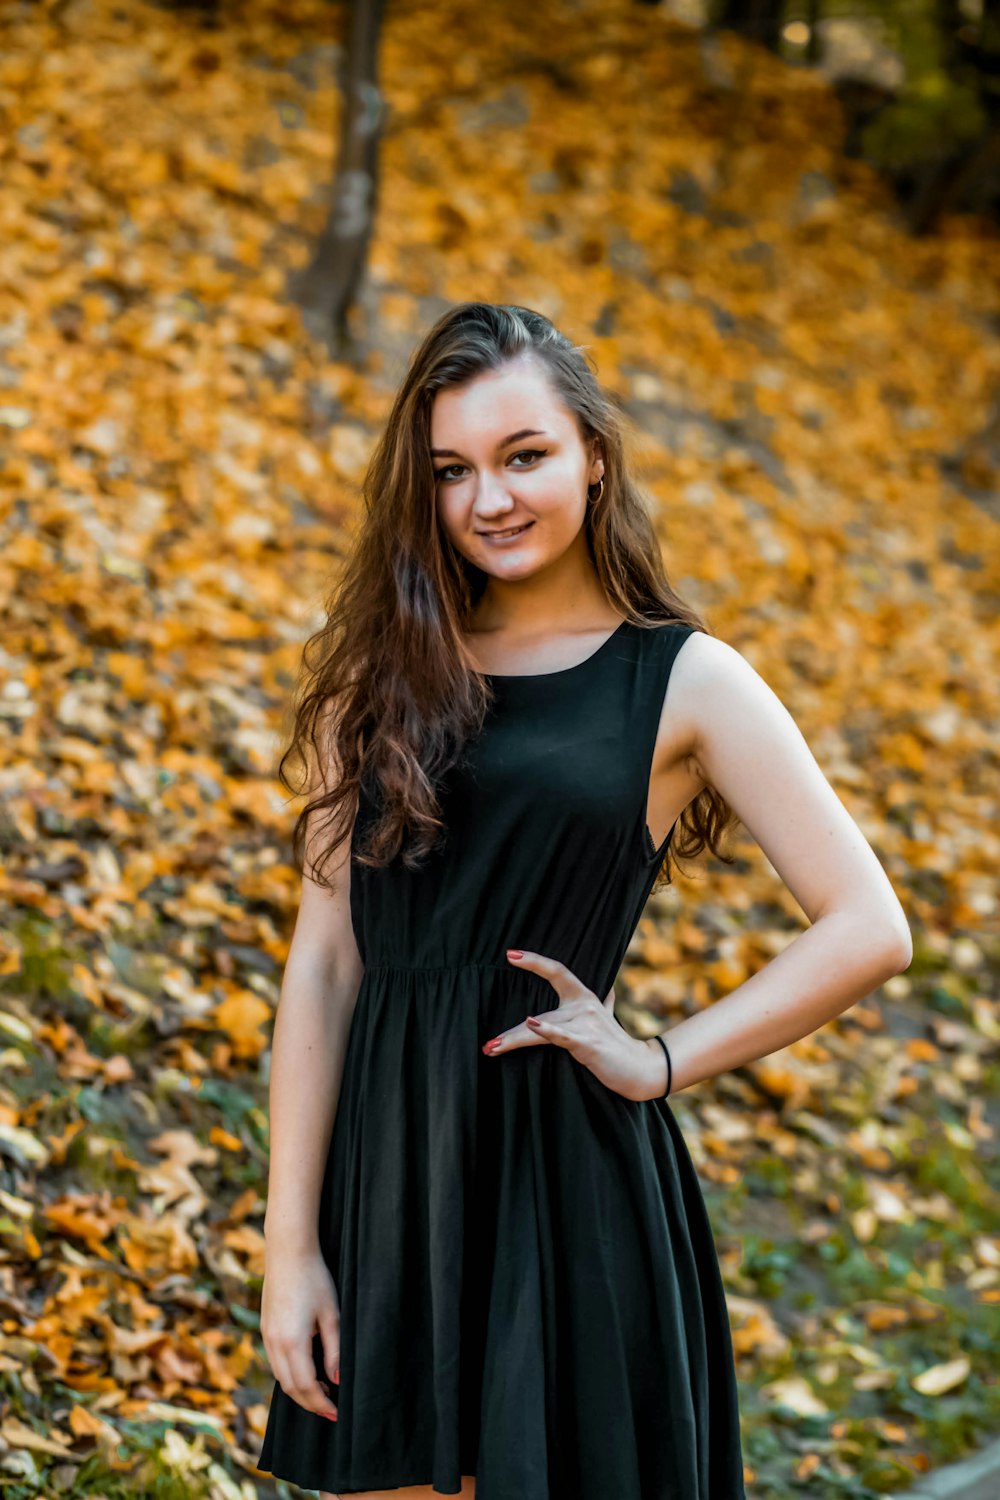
258 965 745 1500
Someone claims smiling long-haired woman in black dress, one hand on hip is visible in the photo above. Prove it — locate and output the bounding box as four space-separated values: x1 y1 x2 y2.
259 303 910 1500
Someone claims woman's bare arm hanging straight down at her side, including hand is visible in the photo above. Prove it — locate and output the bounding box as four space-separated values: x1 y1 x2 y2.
261 714 364 1416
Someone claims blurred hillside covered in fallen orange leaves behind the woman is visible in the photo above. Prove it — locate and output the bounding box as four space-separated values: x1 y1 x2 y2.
0 0 1000 1500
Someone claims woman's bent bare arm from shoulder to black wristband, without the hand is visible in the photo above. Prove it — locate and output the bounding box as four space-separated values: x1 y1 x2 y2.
646 636 913 1098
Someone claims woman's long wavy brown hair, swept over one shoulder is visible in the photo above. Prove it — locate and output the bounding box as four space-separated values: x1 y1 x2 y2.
277 302 735 890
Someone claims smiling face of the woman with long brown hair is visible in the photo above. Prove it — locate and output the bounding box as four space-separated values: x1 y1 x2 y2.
430 357 604 579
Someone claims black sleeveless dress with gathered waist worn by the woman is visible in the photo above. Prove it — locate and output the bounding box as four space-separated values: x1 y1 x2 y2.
258 621 745 1500
